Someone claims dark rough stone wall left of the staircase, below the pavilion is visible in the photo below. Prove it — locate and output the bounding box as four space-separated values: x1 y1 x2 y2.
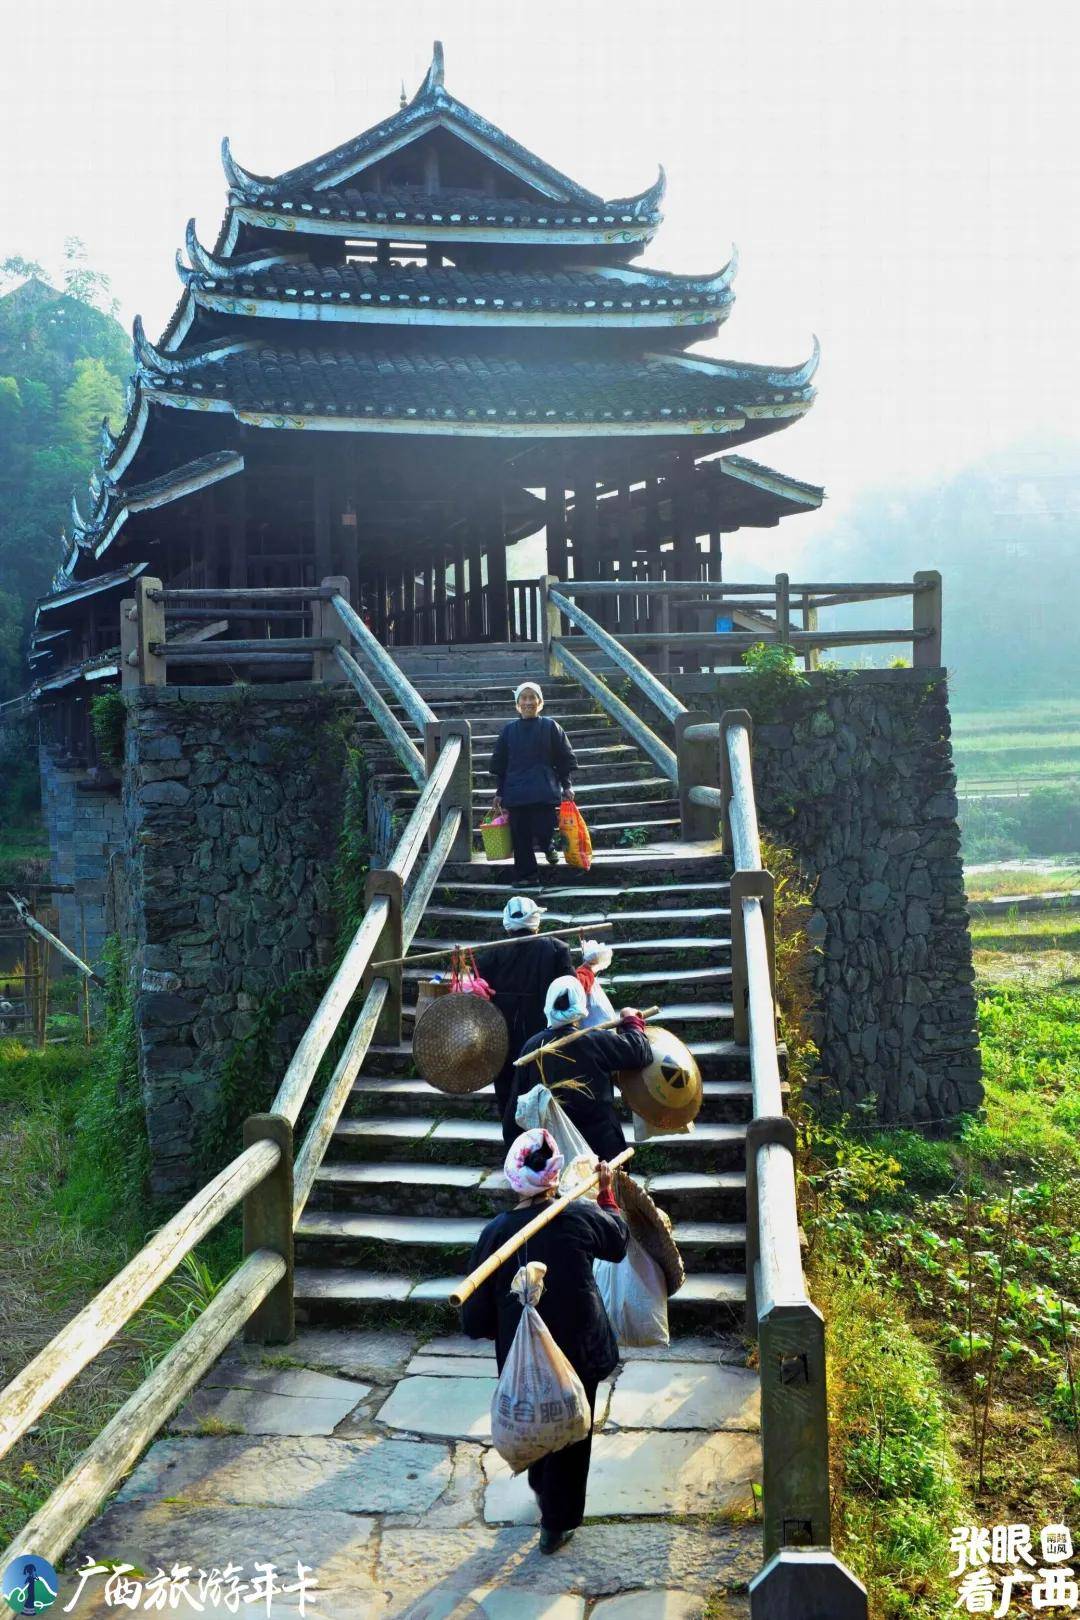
123 682 355 1194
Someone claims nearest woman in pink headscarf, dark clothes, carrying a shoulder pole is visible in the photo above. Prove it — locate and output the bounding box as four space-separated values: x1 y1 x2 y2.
461 1131 630 1554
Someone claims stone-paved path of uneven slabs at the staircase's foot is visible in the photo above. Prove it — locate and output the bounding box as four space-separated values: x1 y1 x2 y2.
68 1328 761 1620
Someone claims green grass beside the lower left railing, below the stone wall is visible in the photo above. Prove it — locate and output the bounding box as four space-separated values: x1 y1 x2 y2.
0 1017 238 1544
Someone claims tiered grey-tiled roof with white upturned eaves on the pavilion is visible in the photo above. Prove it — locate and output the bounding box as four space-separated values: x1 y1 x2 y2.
36 45 819 683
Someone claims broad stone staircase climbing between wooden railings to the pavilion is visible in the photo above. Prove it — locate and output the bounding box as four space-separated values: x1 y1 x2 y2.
295 658 786 1333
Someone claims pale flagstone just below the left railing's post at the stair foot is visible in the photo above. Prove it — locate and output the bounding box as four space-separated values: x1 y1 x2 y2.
170 1366 371 1435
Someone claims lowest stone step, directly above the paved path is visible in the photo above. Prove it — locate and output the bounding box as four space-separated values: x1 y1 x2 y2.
295 1265 746 1335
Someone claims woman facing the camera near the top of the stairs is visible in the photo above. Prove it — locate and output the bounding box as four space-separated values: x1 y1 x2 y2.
491 680 578 889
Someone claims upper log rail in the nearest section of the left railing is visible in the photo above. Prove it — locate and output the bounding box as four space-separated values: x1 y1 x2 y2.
0 1142 280 1456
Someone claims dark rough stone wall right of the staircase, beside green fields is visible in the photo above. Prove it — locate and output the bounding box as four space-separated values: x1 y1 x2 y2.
672 669 983 1124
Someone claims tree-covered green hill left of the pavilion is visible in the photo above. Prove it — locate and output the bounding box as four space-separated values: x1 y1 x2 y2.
0 275 131 698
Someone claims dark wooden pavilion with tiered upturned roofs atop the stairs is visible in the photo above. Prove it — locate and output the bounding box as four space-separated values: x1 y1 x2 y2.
31 44 823 729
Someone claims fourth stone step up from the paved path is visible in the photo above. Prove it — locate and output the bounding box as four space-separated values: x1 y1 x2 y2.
334 1111 746 1175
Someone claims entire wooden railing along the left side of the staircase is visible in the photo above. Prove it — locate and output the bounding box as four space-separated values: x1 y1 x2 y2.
0 578 473 1568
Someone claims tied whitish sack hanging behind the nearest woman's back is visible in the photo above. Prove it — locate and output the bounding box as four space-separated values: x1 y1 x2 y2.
491 1260 593 1474
